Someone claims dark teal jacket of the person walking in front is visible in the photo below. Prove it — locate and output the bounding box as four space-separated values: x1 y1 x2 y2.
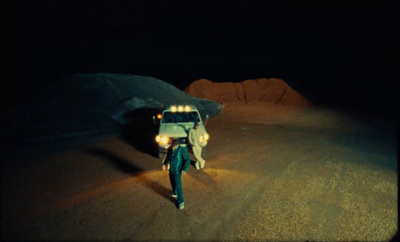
163 145 190 174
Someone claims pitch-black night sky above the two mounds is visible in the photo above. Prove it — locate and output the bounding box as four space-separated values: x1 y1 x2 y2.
0 0 399 115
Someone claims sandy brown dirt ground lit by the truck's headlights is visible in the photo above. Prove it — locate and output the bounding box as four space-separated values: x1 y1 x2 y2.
1 105 398 241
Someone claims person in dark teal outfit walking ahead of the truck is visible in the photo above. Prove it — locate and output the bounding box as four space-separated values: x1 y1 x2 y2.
162 139 190 209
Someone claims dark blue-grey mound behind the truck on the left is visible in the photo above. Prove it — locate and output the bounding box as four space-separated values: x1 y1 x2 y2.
2 73 221 140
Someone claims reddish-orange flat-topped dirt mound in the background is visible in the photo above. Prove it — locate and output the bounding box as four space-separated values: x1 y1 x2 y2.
184 78 308 106
